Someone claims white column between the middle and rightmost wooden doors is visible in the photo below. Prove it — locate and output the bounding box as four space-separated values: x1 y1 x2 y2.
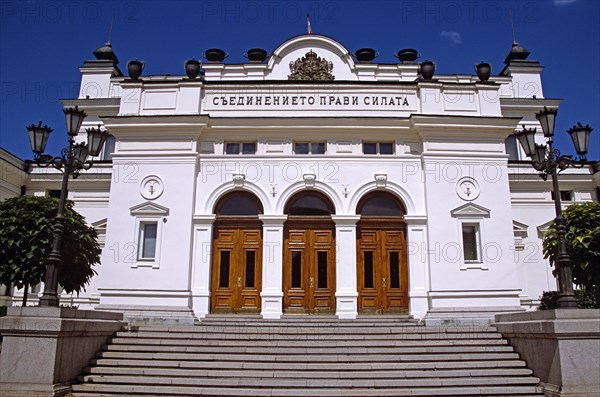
331 215 360 318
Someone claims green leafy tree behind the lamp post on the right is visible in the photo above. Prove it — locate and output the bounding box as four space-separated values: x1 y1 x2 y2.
544 202 600 302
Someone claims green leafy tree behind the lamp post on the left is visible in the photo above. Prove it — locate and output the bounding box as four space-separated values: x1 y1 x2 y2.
0 196 101 303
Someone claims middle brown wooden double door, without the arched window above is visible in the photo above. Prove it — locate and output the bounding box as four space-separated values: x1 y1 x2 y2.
283 221 335 313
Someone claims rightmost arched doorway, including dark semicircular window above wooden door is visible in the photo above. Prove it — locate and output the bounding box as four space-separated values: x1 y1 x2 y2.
356 192 408 313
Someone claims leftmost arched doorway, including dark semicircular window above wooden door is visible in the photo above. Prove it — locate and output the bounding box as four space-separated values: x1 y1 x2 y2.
211 191 263 313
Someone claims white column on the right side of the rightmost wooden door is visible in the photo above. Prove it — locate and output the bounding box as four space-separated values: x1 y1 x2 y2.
404 216 429 319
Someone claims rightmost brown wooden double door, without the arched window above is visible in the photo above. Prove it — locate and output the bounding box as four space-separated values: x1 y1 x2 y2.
357 226 408 313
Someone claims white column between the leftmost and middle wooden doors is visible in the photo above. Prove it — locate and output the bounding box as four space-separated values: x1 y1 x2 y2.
258 215 287 318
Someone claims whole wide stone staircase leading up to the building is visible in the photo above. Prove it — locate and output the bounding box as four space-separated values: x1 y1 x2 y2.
73 315 542 397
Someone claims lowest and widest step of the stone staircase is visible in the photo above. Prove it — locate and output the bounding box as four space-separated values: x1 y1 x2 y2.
73 384 540 397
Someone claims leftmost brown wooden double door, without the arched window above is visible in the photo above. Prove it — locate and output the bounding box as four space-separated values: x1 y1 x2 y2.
211 227 262 313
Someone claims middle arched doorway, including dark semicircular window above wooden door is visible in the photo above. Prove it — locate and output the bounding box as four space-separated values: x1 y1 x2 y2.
283 190 335 313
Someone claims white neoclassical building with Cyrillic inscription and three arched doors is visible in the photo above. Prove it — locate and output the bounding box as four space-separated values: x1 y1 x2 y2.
3 35 600 322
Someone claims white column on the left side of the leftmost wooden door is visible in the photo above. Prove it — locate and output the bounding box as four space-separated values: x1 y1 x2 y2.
191 215 215 318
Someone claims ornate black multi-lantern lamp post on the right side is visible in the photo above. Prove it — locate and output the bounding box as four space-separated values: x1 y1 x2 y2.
515 106 592 309
